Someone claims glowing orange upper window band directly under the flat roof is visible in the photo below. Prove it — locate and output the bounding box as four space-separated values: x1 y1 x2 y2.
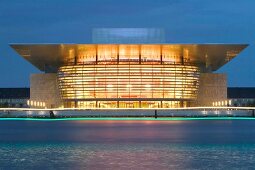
65 44 190 65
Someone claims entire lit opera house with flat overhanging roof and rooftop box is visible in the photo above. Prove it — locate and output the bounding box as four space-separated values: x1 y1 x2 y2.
11 28 248 109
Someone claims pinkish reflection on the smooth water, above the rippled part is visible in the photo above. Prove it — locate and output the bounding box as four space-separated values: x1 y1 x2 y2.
69 120 185 142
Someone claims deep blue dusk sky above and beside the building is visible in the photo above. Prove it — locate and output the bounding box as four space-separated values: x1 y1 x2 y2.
0 0 255 87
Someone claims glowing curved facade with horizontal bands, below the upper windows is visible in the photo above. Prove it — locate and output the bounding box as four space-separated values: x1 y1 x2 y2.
58 64 199 108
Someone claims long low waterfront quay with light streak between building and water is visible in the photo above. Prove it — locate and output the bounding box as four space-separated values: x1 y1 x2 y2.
0 107 255 118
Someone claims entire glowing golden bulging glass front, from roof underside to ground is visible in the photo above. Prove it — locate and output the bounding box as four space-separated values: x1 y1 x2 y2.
58 45 199 108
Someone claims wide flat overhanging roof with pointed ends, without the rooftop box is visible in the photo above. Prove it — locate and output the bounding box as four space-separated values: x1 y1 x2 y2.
10 44 248 71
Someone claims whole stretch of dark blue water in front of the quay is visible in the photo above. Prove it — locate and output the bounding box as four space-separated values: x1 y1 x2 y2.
0 117 255 170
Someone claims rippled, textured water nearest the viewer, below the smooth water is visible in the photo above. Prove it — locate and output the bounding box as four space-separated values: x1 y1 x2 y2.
0 143 255 169
